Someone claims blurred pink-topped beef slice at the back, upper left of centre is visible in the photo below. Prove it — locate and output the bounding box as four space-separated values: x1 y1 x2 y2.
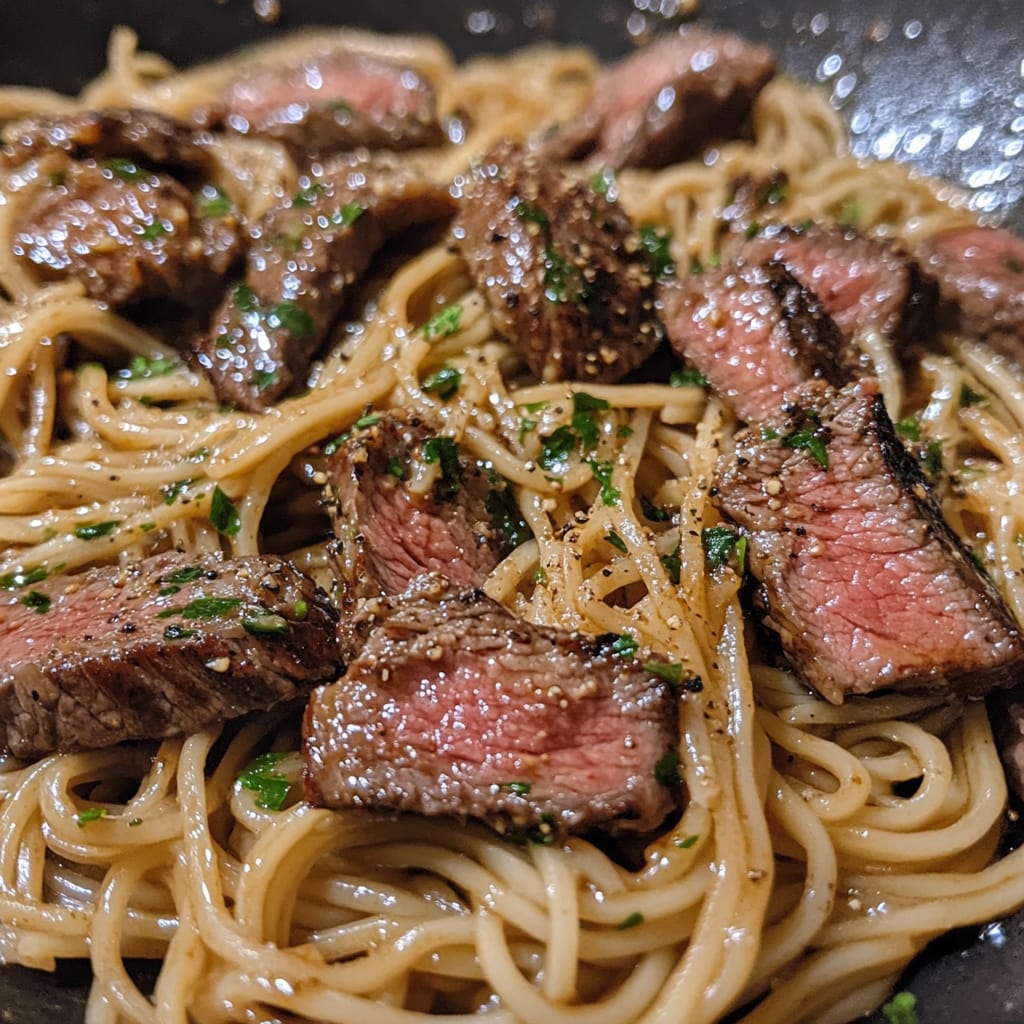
219 50 445 161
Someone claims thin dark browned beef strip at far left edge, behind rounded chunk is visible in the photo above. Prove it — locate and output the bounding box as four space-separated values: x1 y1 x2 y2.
0 108 211 171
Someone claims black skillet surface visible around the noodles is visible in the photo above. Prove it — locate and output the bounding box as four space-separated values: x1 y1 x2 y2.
0 0 1024 1024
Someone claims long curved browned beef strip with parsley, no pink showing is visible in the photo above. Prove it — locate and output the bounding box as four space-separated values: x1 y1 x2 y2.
196 153 455 412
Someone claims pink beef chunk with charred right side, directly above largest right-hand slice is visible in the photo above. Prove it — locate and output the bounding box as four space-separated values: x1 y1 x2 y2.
660 261 855 422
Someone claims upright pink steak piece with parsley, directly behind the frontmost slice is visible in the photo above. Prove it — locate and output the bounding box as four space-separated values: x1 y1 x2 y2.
327 411 504 607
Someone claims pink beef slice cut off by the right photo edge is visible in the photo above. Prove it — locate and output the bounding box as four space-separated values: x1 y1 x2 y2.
921 226 1024 367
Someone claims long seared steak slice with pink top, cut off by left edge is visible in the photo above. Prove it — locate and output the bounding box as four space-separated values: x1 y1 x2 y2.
0 555 341 758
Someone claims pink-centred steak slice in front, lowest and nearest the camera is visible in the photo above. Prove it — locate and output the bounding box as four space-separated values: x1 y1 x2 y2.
303 584 678 835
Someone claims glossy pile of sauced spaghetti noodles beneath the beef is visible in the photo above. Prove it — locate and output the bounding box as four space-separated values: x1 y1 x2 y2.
0 24 1024 1024
